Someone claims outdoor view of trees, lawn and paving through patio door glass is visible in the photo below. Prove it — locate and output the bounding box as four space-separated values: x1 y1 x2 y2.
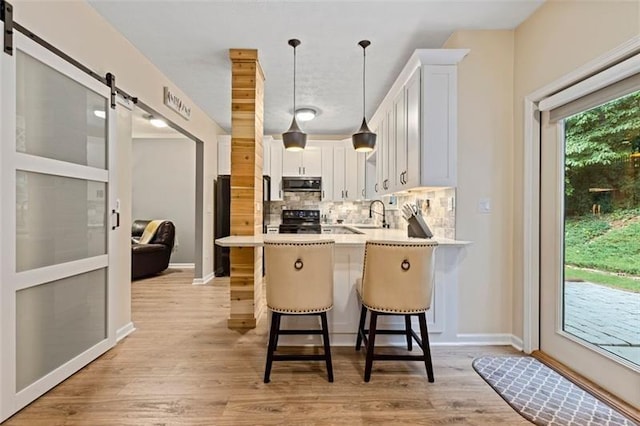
563 91 640 365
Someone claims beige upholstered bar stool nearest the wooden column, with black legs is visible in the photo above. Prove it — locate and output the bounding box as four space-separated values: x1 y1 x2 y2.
264 240 335 383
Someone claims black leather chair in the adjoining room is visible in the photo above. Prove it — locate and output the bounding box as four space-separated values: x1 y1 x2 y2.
131 220 175 280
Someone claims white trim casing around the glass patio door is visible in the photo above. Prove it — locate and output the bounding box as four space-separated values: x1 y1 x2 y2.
522 36 640 353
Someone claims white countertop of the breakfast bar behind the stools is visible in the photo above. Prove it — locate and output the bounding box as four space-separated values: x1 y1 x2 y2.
215 224 471 247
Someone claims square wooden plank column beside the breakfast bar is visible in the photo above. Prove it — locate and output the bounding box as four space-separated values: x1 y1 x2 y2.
227 49 265 329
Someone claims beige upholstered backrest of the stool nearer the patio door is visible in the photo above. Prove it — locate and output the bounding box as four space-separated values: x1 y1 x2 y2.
361 241 438 313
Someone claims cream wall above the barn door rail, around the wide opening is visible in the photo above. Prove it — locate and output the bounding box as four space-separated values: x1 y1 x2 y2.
12 0 224 328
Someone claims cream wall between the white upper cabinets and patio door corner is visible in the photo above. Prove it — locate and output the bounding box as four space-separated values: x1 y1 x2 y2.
444 31 514 334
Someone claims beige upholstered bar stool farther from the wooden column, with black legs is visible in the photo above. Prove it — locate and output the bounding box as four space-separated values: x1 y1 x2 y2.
356 241 438 382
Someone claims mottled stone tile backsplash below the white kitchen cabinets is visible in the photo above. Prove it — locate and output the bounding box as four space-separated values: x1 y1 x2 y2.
268 188 456 239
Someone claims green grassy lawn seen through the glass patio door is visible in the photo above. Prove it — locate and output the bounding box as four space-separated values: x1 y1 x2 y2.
565 208 640 291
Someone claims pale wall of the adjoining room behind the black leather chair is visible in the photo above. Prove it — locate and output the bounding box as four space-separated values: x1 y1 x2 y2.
132 138 196 263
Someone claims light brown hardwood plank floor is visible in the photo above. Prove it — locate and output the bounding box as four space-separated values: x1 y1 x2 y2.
6 270 530 426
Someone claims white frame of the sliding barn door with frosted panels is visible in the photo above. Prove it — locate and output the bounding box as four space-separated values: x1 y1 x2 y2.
0 32 117 421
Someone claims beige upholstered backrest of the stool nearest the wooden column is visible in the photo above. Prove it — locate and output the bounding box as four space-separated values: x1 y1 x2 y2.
264 241 335 314
